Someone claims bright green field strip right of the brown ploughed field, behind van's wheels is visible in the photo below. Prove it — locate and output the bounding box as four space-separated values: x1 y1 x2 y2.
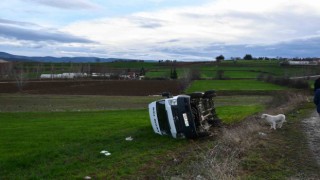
186 80 287 93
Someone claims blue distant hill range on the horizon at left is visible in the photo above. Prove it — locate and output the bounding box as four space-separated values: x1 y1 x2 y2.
0 52 144 63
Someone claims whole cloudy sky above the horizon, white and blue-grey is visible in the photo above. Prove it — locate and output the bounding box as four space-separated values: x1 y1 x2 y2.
0 0 320 60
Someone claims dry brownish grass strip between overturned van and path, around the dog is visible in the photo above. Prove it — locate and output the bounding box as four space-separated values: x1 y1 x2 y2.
162 93 307 179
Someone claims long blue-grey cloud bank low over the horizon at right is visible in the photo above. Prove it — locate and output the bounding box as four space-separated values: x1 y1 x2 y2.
154 36 320 59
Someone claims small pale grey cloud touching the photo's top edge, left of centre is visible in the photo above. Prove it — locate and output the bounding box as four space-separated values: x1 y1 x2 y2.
28 0 99 10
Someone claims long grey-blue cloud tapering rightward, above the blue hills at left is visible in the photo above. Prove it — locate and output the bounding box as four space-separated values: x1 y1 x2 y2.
0 24 93 43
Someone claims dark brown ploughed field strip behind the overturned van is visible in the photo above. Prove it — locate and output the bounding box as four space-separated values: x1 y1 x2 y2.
0 80 180 96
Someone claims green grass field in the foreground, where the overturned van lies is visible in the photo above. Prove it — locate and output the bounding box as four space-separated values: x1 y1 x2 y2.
0 95 269 179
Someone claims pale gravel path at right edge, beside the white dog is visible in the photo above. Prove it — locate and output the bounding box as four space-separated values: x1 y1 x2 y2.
302 111 320 165
